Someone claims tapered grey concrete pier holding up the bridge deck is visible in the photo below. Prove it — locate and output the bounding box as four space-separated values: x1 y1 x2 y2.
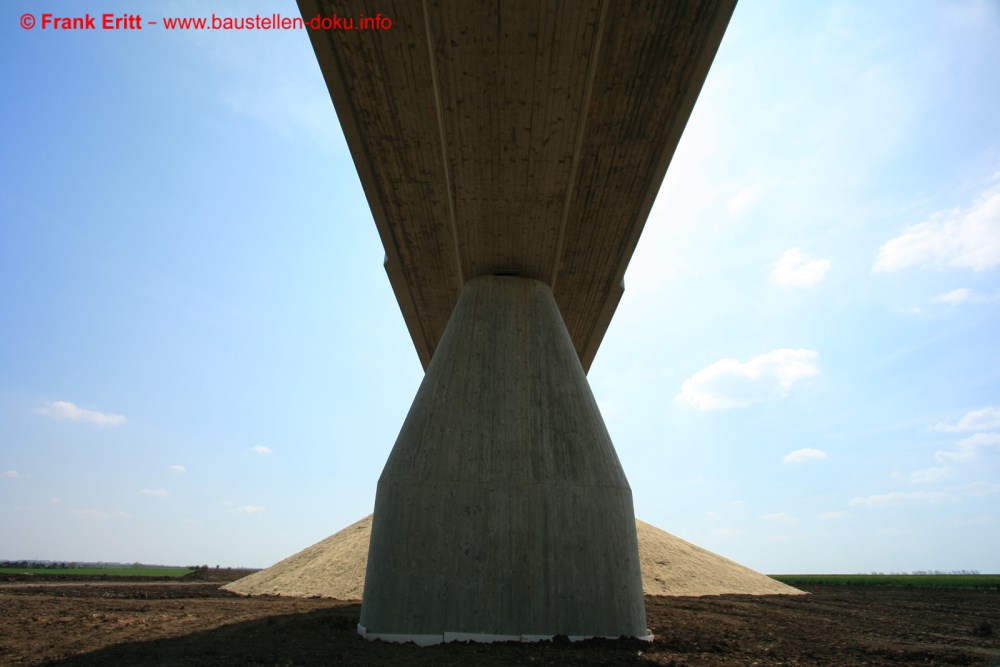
360 276 649 644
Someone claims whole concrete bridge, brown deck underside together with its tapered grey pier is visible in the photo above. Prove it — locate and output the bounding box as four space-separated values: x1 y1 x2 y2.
299 0 735 644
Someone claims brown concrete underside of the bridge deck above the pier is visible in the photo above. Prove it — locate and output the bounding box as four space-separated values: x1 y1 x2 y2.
300 0 736 369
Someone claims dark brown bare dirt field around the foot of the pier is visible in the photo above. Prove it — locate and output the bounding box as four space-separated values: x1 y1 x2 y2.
0 581 1000 667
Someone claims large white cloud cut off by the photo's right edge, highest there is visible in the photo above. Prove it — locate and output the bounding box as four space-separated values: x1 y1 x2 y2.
874 185 1000 271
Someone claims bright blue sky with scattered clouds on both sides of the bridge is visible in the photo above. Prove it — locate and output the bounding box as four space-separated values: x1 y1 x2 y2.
0 0 1000 573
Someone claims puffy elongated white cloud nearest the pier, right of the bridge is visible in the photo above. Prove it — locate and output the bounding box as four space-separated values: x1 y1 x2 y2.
674 349 819 410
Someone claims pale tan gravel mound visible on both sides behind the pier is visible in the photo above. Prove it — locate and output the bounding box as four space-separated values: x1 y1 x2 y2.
222 515 803 600
